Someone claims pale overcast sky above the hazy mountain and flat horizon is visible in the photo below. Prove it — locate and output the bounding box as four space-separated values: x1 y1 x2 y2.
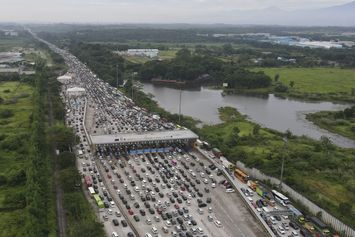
0 0 350 23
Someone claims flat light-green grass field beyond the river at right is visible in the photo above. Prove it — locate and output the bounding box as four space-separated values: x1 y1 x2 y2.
255 68 355 94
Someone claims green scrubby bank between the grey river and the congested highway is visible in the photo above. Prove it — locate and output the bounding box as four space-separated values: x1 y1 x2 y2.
127 85 355 226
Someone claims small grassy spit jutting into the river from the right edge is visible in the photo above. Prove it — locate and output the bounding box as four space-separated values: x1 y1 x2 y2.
306 108 355 140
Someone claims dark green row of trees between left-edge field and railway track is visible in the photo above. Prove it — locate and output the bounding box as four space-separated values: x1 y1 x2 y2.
25 68 53 237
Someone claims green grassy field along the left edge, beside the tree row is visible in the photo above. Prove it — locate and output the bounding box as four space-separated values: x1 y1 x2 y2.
0 82 32 237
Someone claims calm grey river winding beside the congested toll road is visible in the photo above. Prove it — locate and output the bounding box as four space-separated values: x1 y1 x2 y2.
142 83 355 148
